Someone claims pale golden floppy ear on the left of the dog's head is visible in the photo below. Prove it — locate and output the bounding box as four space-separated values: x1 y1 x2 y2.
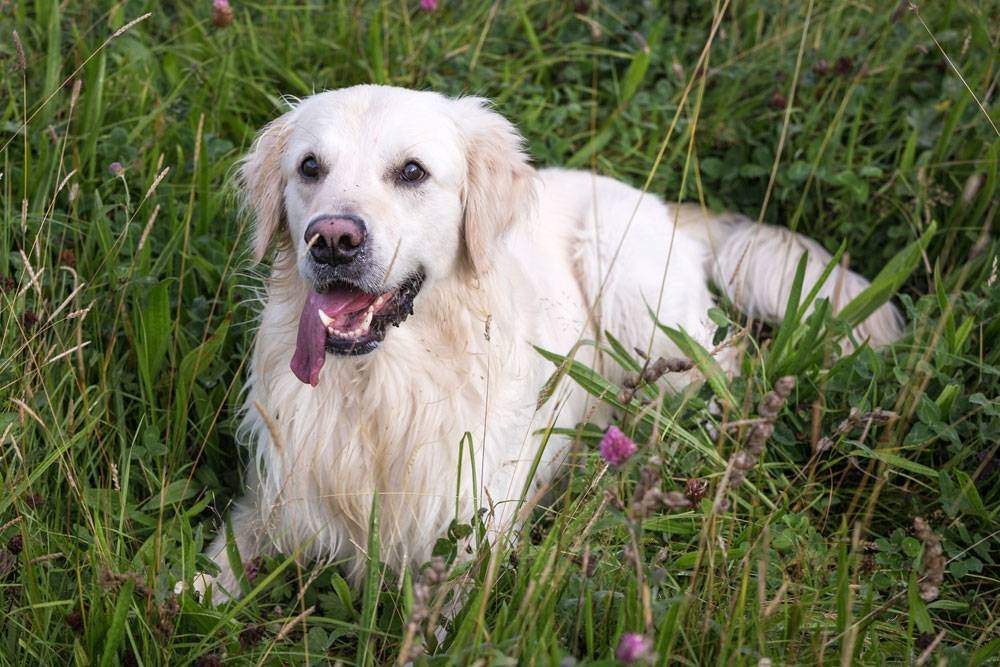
239 113 291 262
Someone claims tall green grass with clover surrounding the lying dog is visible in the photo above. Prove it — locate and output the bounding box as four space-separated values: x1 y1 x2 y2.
0 0 1000 665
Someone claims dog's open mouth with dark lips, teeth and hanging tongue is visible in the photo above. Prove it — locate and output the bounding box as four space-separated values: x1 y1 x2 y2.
291 272 424 387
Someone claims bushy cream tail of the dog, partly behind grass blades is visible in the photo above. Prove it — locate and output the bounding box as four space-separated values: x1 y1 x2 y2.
705 215 903 347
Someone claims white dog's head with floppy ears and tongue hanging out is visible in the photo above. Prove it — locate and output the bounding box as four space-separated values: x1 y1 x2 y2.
240 86 533 385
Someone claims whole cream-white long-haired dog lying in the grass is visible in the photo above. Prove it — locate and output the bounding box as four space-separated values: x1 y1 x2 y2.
196 86 901 601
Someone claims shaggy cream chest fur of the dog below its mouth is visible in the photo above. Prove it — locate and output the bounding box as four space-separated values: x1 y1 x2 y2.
248 342 530 566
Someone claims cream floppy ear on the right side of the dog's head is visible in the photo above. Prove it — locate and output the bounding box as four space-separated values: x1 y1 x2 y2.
456 97 535 276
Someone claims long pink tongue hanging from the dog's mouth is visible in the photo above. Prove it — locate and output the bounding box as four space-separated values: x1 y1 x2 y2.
291 287 377 387
